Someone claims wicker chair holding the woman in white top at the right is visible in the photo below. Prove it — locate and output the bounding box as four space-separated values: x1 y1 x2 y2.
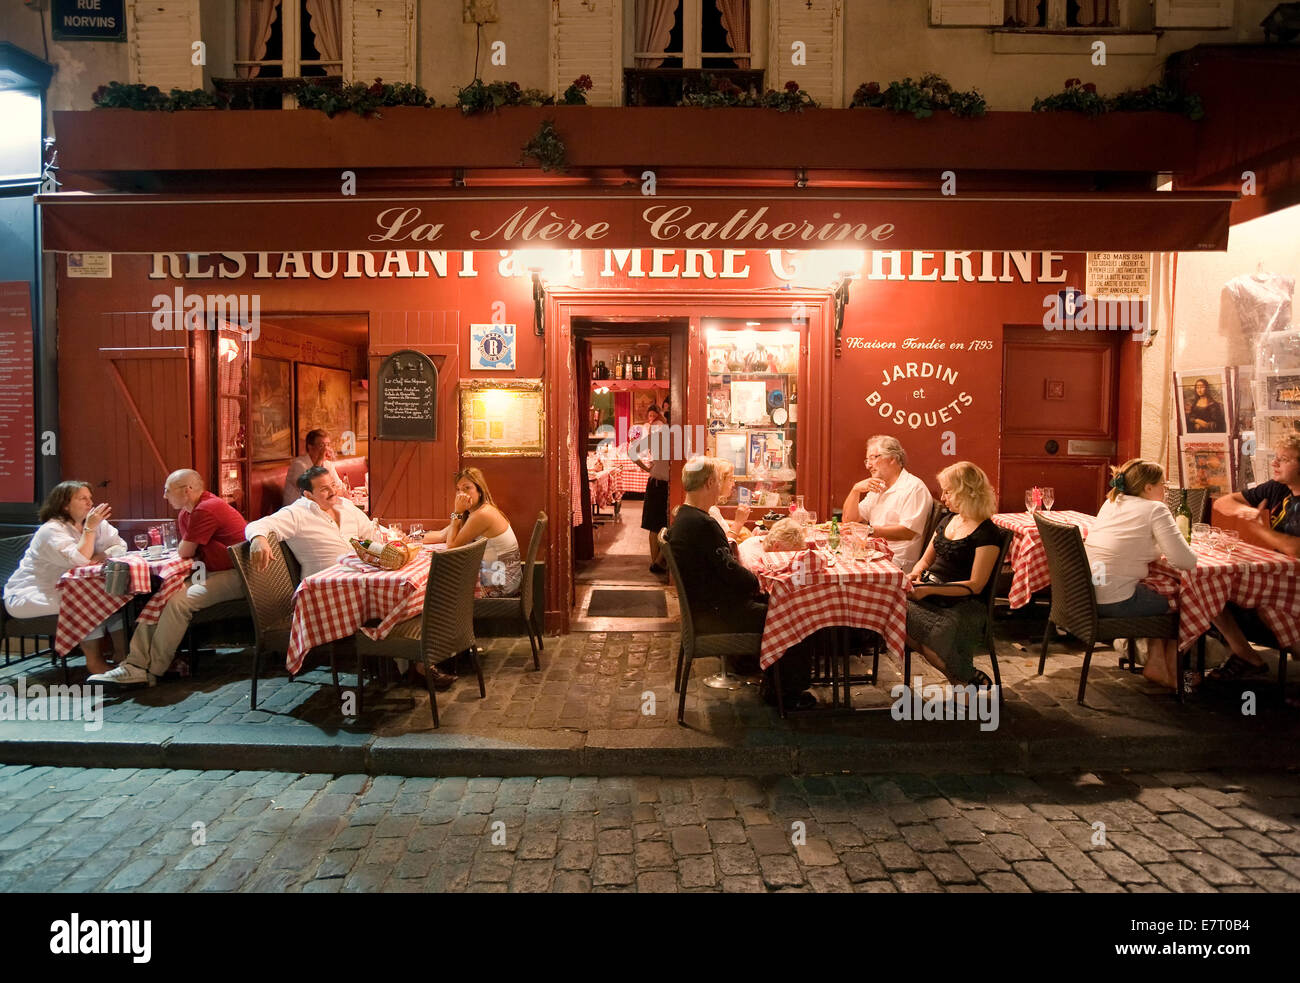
1034 512 1183 705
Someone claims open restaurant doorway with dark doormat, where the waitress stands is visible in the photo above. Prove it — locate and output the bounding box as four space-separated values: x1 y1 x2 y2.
573 317 688 631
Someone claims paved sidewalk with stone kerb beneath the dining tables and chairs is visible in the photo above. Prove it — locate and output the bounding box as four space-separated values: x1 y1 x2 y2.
0 622 1300 776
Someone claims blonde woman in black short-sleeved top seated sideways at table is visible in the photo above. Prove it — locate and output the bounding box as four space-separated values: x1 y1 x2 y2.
906 460 1000 687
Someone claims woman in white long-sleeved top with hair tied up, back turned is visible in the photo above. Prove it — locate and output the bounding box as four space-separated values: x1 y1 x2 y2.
1084 458 1196 688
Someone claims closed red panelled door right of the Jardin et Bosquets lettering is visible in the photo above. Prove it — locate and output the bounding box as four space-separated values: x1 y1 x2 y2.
997 326 1130 514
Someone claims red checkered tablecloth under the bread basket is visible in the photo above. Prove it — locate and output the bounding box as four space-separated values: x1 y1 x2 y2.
285 550 432 674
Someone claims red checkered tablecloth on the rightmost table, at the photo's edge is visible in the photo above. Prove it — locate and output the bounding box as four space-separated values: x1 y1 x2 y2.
1143 544 1300 650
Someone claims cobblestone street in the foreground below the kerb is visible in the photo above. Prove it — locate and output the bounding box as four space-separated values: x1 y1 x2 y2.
0 766 1300 892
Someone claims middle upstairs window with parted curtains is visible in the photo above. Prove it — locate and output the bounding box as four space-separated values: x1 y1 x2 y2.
633 0 751 69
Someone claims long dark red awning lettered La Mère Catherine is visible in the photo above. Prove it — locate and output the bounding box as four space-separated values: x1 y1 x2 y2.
36 189 1236 254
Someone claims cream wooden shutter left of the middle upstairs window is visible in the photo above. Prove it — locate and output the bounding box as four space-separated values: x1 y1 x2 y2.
550 0 623 105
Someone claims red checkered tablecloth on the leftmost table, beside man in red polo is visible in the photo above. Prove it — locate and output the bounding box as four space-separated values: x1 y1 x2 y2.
55 553 194 655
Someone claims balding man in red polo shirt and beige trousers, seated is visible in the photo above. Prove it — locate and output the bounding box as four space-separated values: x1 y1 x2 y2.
86 468 244 687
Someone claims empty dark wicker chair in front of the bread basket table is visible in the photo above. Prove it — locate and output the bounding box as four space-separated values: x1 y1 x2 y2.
354 540 488 727
